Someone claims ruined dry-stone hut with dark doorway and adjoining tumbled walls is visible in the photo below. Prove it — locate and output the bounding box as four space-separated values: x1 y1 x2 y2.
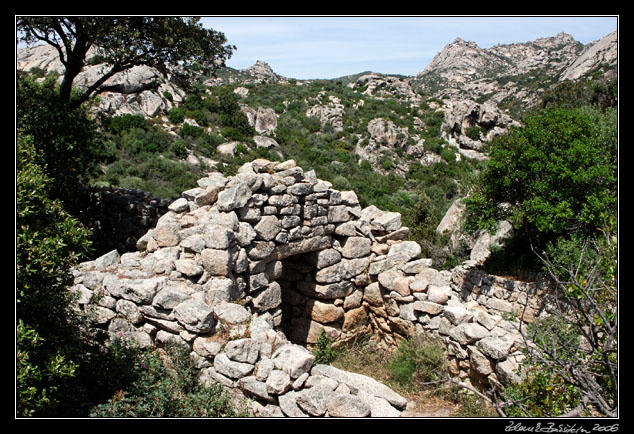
71 160 543 417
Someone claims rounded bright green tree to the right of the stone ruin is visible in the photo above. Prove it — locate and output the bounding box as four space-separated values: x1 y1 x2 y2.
465 107 617 247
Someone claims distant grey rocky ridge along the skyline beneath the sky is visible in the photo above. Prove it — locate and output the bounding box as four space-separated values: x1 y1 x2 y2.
17 30 618 117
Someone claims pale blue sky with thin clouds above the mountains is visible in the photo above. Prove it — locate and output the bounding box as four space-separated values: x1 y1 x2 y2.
202 16 618 79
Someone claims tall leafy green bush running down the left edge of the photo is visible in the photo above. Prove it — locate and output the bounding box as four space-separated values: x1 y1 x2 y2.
15 134 89 416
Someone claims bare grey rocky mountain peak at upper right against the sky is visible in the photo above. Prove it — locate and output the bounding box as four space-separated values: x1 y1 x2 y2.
413 31 617 117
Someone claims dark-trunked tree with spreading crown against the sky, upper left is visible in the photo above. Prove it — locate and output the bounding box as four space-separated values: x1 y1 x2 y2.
17 16 235 107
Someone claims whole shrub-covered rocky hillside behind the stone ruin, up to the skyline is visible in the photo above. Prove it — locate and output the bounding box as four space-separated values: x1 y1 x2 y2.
17 28 618 264
